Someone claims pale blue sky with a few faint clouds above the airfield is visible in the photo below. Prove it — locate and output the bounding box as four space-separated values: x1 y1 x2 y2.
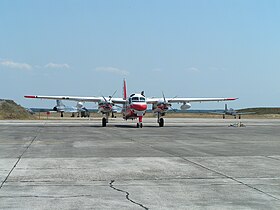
0 0 280 109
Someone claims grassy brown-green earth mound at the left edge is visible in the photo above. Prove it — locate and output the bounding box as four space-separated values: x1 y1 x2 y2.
0 99 35 120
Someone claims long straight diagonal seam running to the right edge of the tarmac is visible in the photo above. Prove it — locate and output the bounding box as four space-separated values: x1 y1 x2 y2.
129 138 280 201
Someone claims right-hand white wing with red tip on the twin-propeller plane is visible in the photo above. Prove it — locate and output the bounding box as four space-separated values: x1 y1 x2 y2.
147 98 237 104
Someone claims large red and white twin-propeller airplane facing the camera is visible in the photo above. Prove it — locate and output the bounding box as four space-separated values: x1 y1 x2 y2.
24 80 237 128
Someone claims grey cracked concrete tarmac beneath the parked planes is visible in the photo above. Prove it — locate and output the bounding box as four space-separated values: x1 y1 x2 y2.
0 118 280 210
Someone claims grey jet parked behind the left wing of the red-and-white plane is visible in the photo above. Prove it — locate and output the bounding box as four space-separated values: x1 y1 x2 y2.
53 99 89 117
